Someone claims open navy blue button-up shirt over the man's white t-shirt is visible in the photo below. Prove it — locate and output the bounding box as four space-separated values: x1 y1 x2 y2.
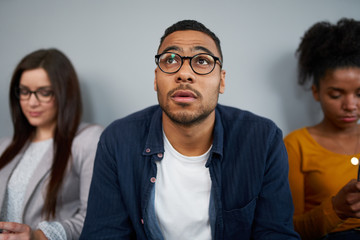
80 104 300 240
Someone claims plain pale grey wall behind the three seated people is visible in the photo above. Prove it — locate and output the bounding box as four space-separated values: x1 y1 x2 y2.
0 0 360 137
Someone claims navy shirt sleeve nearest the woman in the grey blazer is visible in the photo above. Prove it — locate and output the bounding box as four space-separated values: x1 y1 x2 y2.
80 132 134 240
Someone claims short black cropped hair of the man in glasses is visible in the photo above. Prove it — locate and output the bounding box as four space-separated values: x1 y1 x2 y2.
158 20 224 62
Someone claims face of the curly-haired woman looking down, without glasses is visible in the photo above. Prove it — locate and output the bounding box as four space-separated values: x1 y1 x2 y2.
312 67 360 129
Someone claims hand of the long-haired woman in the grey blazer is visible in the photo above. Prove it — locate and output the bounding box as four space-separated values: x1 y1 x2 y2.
0 222 47 240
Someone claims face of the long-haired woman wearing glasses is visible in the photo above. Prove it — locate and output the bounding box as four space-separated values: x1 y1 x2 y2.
19 68 57 131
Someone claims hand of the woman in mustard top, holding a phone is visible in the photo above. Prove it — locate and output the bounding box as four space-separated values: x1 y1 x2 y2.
332 179 360 220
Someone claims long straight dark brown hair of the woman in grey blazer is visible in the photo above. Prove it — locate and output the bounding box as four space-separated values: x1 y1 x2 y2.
0 49 82 220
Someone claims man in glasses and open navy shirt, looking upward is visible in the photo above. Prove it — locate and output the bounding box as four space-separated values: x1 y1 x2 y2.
81 20 299 240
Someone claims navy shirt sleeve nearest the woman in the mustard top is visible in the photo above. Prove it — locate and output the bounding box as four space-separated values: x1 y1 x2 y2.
253 126 299 240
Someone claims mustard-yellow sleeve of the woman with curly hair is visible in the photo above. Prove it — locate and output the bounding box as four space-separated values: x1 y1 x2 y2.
285 134 343 240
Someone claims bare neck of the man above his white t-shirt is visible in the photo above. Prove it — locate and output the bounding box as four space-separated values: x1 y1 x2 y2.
163 111 215 156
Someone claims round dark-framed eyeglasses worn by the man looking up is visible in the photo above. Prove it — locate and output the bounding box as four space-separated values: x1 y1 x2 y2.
155 52 222 75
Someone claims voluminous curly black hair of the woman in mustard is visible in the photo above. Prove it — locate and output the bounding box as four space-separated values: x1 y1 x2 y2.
296 18 360 87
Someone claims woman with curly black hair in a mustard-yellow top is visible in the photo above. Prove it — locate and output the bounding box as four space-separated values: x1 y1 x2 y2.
284 18 360 240
